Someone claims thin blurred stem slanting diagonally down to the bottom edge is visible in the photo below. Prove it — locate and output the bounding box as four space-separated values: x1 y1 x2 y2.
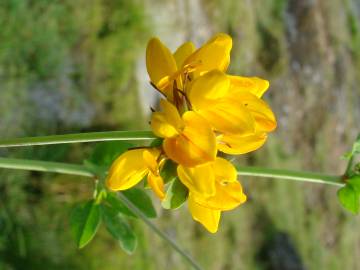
118 192 202 270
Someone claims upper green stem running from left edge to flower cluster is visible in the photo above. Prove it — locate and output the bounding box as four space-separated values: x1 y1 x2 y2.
0 131 157 147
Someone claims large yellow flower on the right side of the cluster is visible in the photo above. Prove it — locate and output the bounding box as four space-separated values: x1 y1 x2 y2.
187 70 276 154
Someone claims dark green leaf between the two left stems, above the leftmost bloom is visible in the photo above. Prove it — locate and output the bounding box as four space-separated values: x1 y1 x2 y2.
88 141 134 168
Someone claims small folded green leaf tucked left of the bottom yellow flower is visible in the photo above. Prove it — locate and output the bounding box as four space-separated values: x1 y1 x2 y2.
161 178 188 209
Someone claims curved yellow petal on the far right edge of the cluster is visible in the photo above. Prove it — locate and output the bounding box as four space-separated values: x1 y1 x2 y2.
231 91 276 132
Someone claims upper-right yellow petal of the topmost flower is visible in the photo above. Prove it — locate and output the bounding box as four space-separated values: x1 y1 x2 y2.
184 33 232 74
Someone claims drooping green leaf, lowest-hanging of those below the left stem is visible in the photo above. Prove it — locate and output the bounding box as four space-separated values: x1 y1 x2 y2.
101 205 137 254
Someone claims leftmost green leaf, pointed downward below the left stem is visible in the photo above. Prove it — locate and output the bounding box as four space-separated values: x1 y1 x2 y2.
70 200 101 248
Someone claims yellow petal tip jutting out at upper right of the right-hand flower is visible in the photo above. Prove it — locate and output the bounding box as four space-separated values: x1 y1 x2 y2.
228 75 270 98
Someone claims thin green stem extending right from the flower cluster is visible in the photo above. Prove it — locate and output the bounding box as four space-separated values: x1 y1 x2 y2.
237 166 344 186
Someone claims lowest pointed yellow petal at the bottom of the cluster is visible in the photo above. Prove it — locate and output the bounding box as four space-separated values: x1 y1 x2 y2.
188 193 221 233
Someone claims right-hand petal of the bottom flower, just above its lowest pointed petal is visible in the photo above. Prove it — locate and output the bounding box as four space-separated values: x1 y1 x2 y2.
193 181 246 211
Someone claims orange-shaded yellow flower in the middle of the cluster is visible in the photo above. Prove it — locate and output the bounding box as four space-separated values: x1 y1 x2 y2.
151 99 217 167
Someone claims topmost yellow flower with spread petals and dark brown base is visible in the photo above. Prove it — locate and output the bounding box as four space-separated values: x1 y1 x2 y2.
146 34 232 101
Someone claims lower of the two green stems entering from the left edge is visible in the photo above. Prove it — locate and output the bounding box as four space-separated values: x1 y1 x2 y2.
0 157 95 177
